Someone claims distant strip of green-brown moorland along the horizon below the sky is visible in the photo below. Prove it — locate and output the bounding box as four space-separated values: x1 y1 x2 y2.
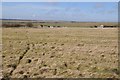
2 20 118 28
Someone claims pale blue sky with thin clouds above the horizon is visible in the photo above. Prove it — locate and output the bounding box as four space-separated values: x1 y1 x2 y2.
2 2 118 22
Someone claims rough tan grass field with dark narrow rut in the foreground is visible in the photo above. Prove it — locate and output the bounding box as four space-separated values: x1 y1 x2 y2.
2 28 119 78
